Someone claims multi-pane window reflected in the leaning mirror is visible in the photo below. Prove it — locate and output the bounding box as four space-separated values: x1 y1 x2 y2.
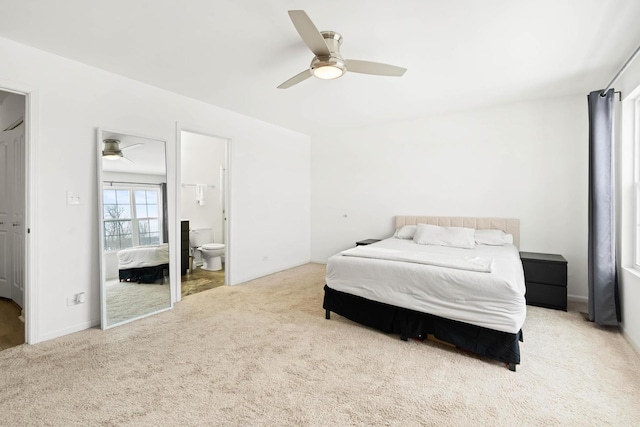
102 187 162 251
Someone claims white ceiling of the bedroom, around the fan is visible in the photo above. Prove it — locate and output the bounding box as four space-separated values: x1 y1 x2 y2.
0 0 640 134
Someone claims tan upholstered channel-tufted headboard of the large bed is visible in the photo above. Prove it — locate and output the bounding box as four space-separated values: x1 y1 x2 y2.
396 216 520 248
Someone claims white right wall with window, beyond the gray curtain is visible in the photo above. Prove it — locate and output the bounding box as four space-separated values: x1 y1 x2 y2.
615 58 640 351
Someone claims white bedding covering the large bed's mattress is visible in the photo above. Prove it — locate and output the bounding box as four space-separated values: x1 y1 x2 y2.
326 238 526 333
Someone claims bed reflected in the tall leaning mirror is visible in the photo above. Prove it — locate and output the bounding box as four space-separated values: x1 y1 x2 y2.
118 243 169 284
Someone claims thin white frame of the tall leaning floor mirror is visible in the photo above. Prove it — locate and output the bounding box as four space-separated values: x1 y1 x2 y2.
96 128 177 329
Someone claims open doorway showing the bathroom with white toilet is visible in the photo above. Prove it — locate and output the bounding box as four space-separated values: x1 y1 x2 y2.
180 130 229 298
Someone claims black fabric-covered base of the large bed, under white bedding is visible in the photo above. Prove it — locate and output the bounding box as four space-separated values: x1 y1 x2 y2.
322 285 522 372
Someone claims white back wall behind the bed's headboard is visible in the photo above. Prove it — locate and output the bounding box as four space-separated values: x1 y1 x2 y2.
311 96 588 299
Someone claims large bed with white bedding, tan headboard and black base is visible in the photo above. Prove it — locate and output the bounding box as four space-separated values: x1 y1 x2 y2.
323 216 526 371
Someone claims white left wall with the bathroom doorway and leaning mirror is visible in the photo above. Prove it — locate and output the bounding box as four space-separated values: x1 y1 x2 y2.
0 38 310 342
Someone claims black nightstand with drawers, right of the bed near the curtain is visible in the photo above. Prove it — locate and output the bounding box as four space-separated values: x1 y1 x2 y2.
520 252 567 311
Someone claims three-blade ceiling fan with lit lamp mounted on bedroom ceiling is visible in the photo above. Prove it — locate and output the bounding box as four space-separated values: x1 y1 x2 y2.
278 10 407 89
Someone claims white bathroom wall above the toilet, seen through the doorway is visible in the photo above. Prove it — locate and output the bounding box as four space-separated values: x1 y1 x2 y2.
180 131 226 264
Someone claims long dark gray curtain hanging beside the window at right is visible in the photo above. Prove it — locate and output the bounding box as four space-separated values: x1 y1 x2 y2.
588 89 620 326
